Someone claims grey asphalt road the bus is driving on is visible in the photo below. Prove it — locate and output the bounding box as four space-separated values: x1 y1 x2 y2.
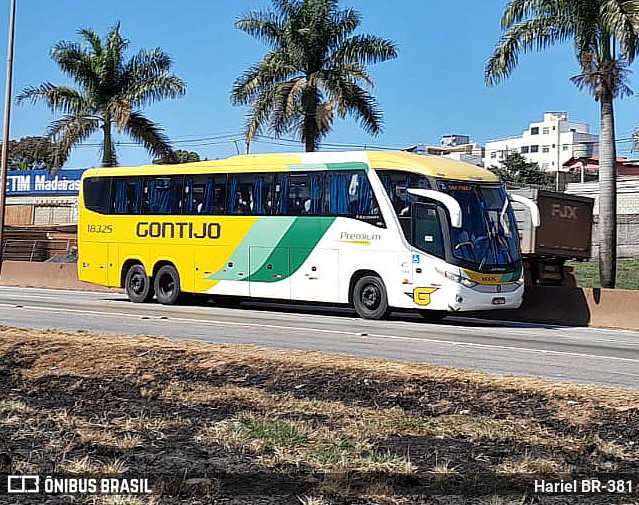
0 287 639 390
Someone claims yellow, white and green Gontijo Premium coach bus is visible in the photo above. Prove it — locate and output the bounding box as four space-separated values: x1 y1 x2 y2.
78 151 534 319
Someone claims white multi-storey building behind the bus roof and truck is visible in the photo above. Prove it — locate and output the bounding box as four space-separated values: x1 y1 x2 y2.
484 112 599 172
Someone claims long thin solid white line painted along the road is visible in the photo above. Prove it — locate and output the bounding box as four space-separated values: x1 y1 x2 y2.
5 303 639 363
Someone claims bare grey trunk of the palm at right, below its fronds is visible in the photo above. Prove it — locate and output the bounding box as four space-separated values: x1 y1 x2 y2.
599 92 617 288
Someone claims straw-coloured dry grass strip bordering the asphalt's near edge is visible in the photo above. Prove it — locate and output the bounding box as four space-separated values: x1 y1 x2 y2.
0 327 639 409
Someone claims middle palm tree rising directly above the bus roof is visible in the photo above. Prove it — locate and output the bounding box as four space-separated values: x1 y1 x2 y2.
231 0 397 151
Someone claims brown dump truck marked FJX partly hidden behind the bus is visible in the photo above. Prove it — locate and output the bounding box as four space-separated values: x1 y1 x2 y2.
509 188 594 285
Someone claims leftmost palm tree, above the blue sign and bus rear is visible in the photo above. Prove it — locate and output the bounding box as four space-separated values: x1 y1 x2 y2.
17 23 186 166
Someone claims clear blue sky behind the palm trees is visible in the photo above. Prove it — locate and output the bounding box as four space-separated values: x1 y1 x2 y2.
0 0 639 168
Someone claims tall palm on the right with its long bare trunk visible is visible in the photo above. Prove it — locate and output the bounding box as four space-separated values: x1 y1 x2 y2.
486 0 639 288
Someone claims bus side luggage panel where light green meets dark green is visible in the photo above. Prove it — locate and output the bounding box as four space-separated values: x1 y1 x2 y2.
249 246 291 300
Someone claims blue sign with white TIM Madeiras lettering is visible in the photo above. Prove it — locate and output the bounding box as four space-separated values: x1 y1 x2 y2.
7 170 84 196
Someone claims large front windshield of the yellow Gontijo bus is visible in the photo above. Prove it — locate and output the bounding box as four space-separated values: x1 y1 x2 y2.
437 180 520 271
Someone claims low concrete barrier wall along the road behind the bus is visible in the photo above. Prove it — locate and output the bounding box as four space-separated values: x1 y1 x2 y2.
0 261 639 330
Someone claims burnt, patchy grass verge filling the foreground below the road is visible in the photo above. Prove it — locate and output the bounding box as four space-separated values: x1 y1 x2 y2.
0 327 639 505
